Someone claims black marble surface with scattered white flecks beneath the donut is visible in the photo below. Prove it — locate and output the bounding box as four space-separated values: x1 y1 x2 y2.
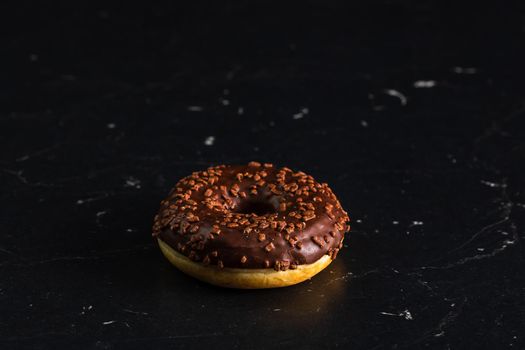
0 1 525 349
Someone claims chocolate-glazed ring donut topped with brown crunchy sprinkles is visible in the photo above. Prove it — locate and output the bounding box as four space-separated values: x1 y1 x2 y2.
152 162 350 289
